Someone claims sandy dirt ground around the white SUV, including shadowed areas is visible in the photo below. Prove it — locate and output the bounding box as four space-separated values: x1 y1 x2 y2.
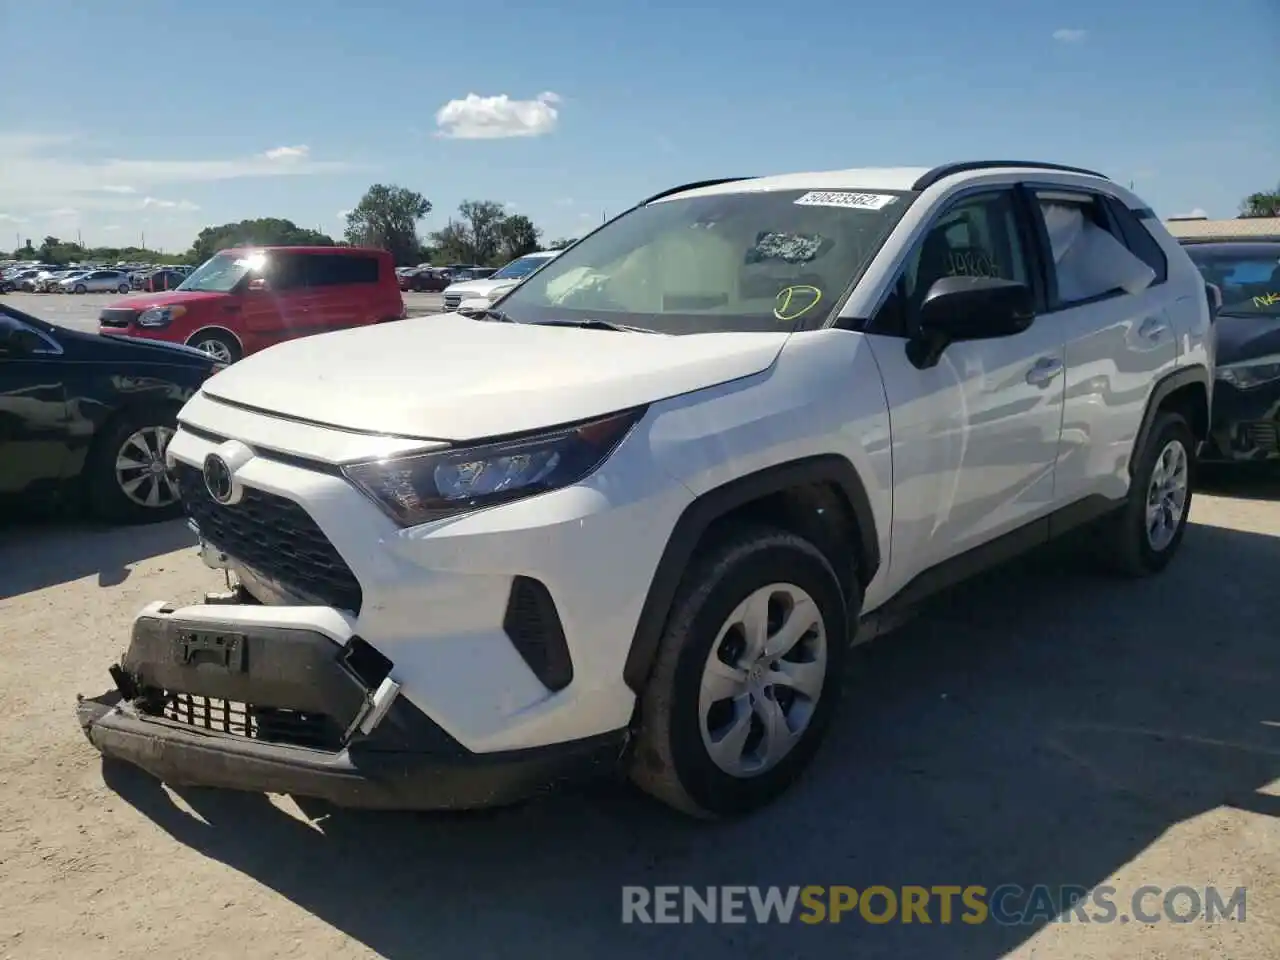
0 480 1280 960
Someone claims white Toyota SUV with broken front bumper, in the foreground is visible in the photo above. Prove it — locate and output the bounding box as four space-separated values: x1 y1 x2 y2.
79 163 1213 817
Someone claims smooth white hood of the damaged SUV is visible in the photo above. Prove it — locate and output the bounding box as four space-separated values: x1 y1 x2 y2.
205 314 790 442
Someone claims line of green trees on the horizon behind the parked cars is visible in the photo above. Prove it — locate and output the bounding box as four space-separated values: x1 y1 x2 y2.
3 183 573 266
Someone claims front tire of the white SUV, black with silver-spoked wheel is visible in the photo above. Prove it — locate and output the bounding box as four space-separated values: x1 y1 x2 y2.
627 527 861 819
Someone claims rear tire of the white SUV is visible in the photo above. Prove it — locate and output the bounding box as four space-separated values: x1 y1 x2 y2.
1100 411 1196 577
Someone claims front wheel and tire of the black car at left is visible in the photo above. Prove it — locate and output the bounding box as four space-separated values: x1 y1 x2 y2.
84 407 182 524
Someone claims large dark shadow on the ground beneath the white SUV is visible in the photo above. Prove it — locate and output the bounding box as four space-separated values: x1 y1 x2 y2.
104 526 1280 960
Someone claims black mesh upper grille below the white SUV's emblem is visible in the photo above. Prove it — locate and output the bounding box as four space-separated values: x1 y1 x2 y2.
174 463 364 613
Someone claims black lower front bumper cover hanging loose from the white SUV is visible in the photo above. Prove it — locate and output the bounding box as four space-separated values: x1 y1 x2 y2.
77 612 626 810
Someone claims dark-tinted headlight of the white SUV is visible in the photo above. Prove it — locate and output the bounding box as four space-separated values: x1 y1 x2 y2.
342 407 645 526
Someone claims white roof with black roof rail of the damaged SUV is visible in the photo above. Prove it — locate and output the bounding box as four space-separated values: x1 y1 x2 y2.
645 160 1106 204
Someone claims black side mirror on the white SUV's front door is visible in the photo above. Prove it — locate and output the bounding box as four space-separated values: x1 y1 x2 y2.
908 276 1036 370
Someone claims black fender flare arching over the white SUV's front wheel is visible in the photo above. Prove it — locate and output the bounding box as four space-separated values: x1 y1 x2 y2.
622 454 881 694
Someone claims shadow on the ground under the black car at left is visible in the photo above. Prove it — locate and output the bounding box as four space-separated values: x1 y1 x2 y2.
0 517 196 600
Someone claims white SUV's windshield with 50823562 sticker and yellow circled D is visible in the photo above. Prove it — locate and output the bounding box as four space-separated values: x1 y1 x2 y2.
488 191 913 334
